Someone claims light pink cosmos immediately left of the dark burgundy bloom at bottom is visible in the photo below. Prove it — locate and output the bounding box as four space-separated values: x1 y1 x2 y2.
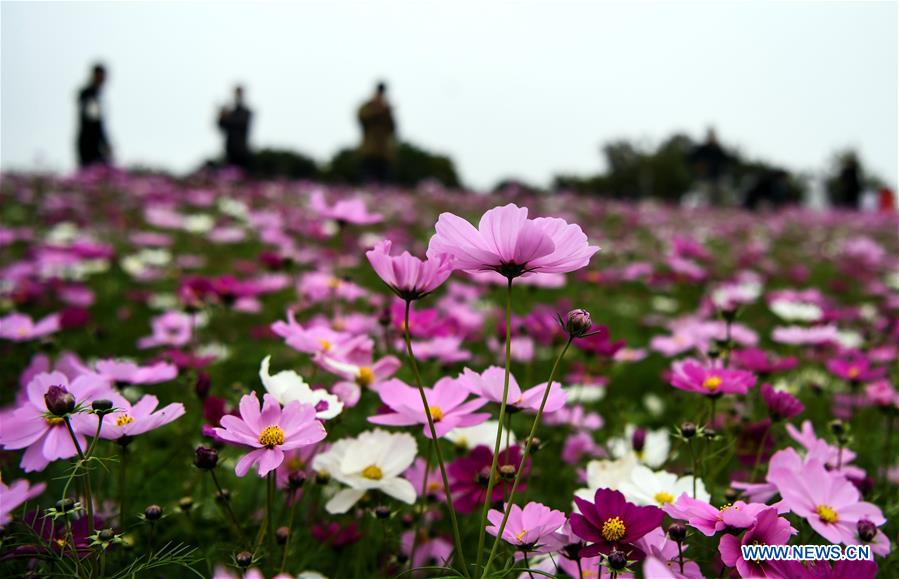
487 502 566 553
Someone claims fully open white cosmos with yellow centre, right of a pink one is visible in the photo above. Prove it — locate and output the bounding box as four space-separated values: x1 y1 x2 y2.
312 429 418 514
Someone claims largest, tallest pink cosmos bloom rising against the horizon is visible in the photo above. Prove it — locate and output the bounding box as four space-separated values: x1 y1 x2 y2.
427 203 599 279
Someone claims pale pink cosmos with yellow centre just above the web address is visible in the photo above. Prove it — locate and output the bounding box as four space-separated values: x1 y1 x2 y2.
769 461 886 545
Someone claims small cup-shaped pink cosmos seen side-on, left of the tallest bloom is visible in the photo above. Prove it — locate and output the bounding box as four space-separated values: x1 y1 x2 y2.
365 240 453 301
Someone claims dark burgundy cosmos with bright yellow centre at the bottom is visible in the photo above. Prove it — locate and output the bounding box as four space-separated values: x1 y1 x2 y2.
571 489 664 559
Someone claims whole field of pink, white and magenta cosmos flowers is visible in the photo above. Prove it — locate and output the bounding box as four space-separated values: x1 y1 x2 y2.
0 170 899 579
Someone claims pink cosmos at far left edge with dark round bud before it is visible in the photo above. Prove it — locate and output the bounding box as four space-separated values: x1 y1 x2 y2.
0 372 112 472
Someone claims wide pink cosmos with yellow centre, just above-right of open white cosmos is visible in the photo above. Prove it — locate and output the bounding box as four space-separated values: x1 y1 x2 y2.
368 377 490 438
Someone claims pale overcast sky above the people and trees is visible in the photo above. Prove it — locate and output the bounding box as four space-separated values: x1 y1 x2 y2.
0 0 897 187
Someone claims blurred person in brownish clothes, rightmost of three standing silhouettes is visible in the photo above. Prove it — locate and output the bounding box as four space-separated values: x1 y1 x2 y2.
358 82 396 183
